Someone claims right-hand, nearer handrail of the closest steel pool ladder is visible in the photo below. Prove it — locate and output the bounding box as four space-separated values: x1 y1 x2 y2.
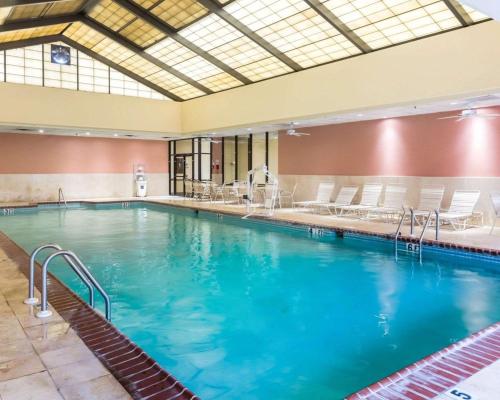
36 250 111 321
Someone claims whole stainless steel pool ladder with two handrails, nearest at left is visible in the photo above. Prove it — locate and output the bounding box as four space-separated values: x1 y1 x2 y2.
24 243 111 321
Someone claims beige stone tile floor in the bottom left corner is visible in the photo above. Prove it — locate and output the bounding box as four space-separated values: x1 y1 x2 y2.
0 249 131 400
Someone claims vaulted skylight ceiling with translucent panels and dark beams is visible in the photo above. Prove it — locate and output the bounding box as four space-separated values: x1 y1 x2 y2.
0 0 487 101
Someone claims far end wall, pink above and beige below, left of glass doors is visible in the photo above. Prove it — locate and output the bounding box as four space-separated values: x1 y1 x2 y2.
0 134 168 203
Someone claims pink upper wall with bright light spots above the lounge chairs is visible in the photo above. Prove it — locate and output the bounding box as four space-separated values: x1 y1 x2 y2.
279 107 500 177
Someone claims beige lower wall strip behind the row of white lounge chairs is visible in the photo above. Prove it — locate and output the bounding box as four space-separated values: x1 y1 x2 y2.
279 175 500 224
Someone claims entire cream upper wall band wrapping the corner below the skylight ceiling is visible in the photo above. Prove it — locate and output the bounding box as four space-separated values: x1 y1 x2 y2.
0 21 500 134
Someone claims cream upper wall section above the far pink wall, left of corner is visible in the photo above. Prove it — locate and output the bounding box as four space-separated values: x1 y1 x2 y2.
0 83 181 136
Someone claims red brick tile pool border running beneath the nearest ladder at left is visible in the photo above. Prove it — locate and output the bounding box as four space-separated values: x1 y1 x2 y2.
0 231 199 400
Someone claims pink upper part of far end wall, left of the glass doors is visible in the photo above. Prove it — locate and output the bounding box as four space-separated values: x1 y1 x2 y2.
0 133 168 174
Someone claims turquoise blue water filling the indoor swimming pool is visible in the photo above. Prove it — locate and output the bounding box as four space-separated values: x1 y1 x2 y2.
0 205 500 400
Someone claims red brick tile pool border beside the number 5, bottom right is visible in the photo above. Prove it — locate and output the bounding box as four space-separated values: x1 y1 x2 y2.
347 322 500 400
